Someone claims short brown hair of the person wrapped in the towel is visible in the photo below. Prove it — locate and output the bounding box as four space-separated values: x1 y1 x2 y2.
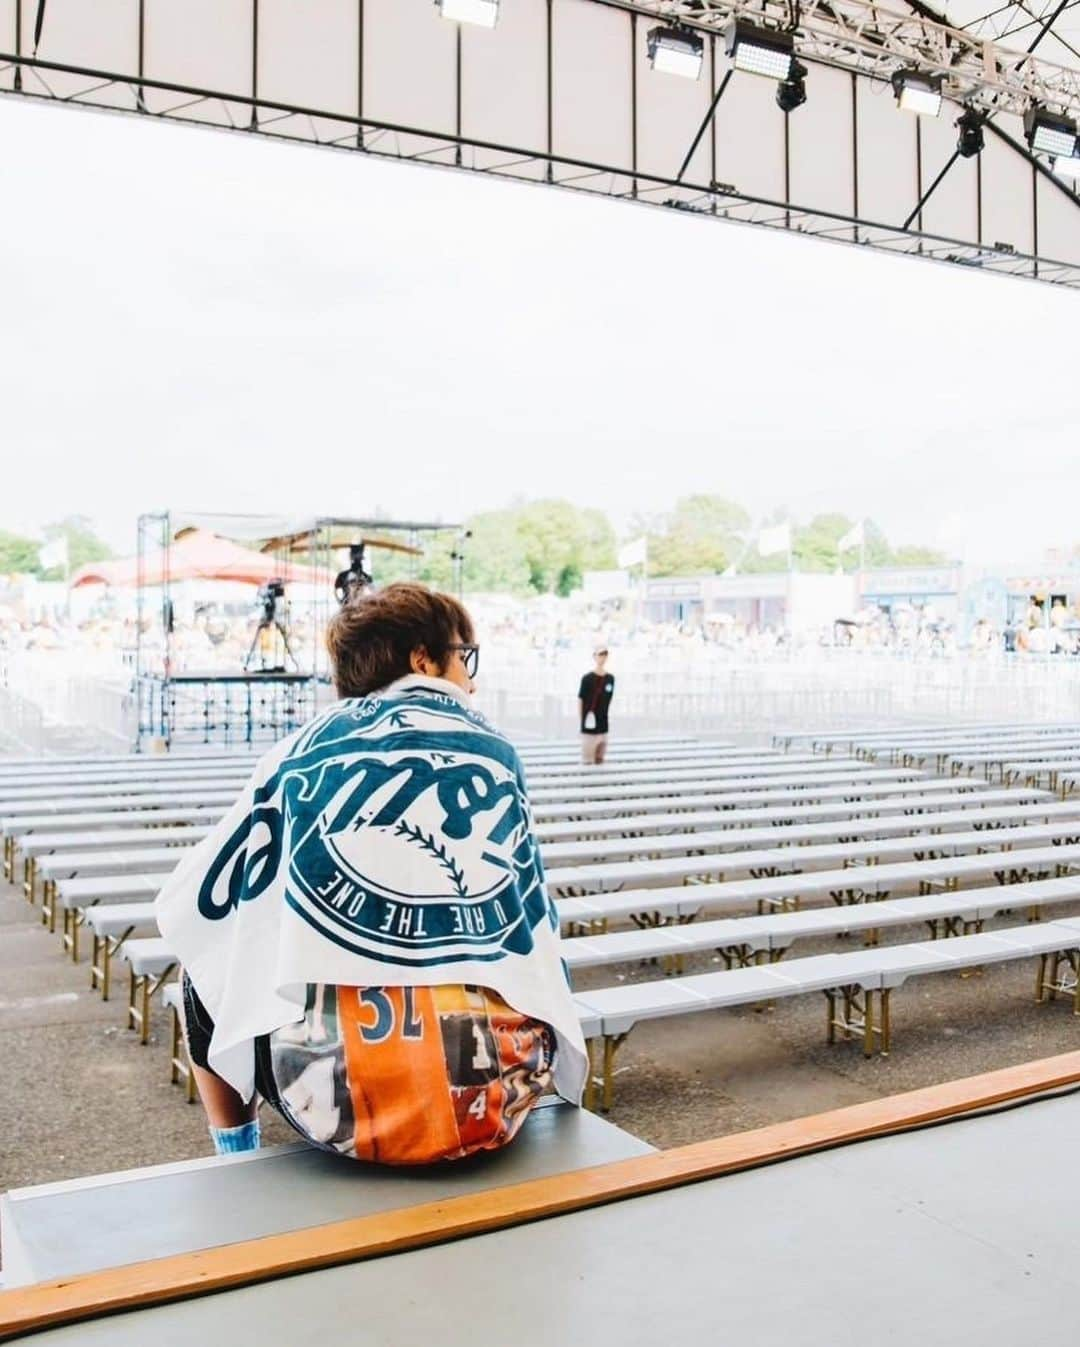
326 582 475 696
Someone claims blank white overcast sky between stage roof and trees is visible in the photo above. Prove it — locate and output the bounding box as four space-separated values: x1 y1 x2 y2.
0 89 1080 560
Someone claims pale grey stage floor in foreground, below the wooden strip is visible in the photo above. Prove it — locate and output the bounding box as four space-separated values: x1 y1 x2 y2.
16 1095 1080 1347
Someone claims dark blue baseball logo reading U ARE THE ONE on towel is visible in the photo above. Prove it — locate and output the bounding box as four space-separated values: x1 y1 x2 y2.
191 700 548 966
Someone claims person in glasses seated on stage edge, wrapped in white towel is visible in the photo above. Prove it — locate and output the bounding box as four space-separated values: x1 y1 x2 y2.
156 585 586 1164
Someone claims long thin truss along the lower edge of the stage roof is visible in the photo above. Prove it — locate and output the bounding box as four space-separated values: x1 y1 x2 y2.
0 53 1080 290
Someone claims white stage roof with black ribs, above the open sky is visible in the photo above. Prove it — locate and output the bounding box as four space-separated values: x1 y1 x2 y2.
0 0 1080 287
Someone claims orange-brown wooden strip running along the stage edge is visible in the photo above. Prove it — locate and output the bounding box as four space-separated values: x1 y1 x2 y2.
0 1052 1080 1342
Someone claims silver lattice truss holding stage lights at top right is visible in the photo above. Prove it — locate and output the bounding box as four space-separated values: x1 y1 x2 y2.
595 0 1080 116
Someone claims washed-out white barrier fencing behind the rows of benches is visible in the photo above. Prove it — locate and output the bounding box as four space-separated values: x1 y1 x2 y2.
0 647 1080 752
